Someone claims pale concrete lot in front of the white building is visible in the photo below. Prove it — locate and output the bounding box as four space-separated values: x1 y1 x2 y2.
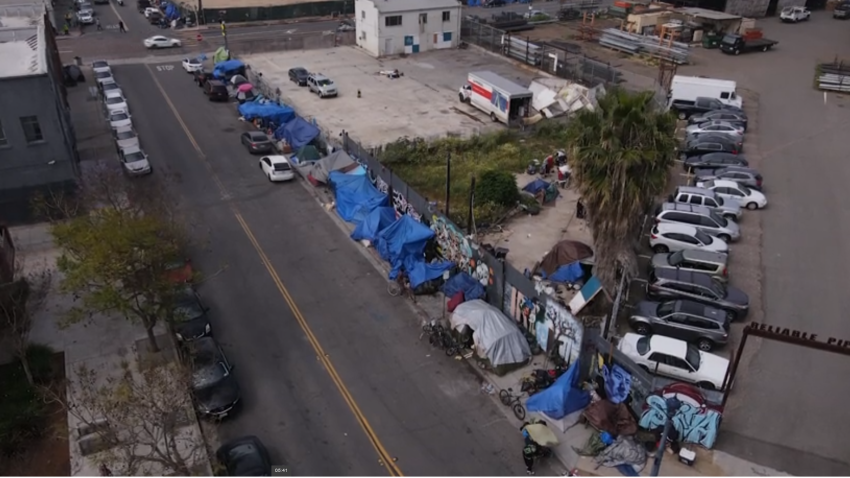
238 47 535 146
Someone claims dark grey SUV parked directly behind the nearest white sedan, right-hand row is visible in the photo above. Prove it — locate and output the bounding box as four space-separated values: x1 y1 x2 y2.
629 300 729 352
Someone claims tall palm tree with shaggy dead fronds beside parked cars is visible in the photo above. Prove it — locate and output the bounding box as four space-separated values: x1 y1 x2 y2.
567 88 676 290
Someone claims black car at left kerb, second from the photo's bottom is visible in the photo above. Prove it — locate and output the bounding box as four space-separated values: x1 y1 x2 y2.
183 337 241 418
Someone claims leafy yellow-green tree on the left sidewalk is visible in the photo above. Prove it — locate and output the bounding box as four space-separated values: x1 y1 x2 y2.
52 206 183 352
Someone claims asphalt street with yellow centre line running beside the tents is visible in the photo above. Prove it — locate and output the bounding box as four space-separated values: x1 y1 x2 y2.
115 63 560 476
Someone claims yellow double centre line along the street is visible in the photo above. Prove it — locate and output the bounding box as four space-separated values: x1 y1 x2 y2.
146 65 404 476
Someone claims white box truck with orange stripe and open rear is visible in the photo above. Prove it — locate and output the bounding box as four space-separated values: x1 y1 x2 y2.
458 71 533 126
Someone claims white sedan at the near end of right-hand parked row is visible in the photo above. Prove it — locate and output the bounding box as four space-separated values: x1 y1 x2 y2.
617 334 729 390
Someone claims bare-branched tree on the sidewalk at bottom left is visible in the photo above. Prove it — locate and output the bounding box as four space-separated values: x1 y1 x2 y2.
53 362 209 476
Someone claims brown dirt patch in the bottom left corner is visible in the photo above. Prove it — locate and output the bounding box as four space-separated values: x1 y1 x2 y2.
0 352 71 476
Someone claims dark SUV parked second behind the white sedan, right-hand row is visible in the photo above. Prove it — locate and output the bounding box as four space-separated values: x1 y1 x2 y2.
646 269 750 320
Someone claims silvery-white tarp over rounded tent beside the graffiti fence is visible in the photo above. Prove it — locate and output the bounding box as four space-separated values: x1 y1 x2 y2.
451 300 531 367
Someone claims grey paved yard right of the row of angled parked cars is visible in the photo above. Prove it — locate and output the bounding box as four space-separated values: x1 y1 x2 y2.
680 12 850 476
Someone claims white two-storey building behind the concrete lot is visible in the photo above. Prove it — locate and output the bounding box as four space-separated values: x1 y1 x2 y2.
354 0 461 57
